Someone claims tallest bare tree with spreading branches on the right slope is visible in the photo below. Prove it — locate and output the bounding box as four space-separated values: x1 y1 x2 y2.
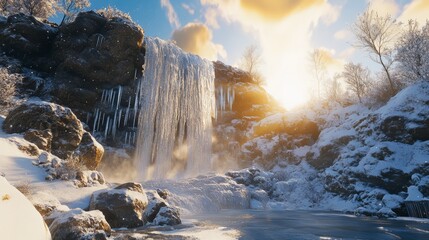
352 8 399 95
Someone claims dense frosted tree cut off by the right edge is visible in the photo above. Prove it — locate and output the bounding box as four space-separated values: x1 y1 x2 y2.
396 20 429 82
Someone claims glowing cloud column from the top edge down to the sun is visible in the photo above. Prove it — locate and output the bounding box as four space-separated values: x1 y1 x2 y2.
200 0 341 105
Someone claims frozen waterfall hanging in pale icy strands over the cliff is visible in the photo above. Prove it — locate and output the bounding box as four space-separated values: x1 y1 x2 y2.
136 37 216 180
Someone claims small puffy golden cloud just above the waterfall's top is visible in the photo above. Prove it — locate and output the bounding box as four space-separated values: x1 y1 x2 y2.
172 23 227 61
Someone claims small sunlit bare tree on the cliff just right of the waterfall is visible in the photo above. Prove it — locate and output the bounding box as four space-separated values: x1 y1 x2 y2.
240 45 265 85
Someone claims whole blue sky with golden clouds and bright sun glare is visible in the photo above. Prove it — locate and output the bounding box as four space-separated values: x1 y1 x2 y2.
81 0 429 108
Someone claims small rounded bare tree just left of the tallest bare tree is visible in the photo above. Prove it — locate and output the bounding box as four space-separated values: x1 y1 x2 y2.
342 63 370 103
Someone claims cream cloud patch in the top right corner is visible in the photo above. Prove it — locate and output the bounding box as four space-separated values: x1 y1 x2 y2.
399 0 429 24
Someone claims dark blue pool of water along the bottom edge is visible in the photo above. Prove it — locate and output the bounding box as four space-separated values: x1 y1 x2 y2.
186 210 429 240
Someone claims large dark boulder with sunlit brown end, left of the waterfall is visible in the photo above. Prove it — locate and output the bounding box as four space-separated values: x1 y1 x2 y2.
3 103 104 170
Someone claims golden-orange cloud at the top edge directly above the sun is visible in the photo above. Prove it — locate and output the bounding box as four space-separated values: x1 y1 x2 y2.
240 0 324 21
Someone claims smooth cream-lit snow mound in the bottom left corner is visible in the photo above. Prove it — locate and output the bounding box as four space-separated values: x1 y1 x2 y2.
0 176 51 240
